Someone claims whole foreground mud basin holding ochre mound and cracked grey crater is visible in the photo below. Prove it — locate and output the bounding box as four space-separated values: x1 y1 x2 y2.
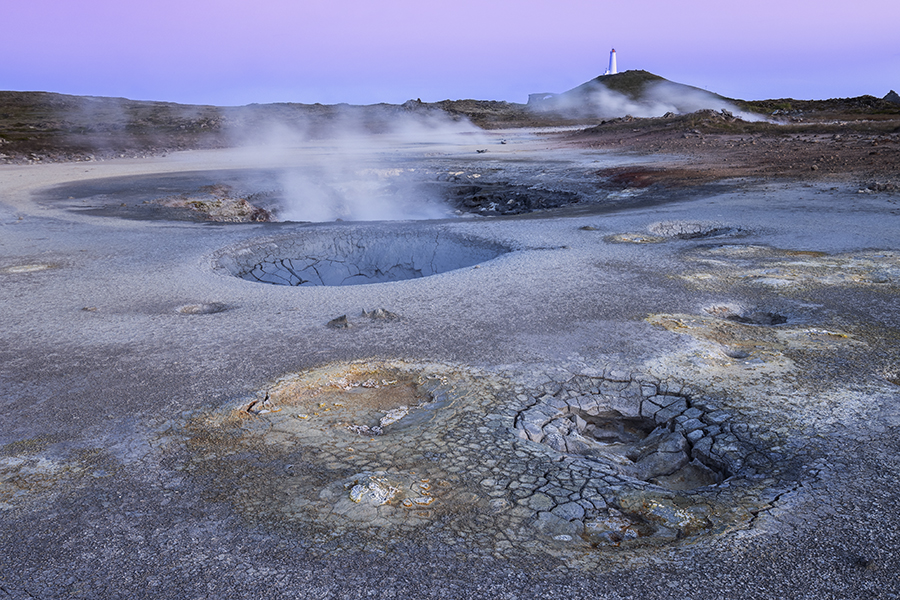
174 362 777 568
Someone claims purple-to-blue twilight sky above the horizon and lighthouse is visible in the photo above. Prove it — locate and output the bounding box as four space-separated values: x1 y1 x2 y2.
0 0 900 105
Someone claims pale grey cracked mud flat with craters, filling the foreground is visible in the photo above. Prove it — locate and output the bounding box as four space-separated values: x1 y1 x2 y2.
0 95 900 598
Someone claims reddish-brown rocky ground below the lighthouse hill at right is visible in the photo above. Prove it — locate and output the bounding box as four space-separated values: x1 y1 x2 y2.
572 103 900 191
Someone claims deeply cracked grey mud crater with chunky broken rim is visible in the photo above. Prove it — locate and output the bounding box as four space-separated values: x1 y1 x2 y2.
516 381 753 491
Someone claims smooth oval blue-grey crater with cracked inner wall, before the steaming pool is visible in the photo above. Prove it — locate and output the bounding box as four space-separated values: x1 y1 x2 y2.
218 228 510 286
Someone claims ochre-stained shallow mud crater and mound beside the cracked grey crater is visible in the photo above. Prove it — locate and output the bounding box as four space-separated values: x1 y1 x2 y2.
178 363 489 542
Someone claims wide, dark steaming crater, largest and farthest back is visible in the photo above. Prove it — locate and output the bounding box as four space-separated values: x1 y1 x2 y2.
37 169 582 223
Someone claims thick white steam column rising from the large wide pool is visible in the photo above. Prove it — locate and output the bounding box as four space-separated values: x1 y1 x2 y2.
229 107 484 222
